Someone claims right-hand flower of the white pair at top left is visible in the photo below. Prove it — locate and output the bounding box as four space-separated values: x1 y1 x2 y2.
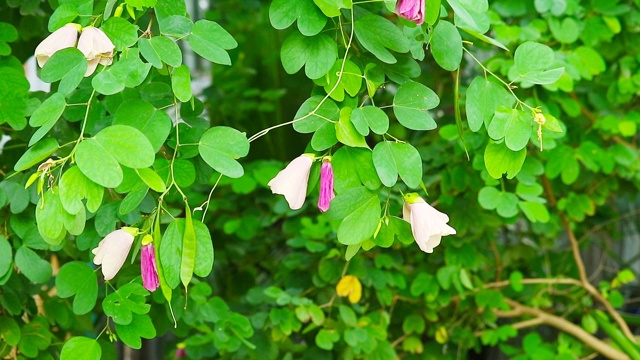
78 26 115 77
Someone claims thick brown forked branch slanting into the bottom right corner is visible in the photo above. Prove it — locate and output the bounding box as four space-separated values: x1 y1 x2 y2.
495 298 629 360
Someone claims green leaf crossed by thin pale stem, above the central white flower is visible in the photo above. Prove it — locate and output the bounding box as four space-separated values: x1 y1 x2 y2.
293 95 340 134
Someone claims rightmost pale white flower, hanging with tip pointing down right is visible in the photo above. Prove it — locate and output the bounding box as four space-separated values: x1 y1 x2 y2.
402 193 456 254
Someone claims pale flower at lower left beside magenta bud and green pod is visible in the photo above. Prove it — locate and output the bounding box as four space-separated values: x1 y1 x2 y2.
91 227 138 281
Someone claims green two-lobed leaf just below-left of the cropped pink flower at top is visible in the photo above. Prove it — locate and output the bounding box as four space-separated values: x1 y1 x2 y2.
354 14 410 64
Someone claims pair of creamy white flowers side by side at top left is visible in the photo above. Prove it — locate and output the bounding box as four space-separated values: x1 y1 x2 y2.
35 24 115 77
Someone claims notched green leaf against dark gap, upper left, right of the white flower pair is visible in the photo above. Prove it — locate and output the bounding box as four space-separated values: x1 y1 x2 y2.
188 20 238 65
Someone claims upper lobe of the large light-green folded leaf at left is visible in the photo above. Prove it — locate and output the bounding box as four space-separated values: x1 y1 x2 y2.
94 125 155 168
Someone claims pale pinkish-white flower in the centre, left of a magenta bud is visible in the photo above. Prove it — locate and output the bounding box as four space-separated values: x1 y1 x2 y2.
267 154 314 210
